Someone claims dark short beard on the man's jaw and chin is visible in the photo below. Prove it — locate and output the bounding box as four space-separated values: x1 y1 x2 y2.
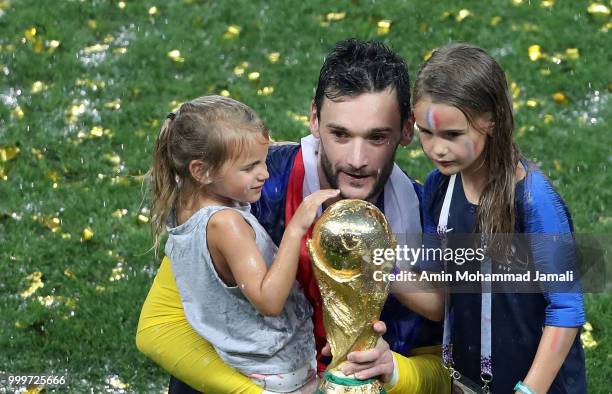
319 140 396 203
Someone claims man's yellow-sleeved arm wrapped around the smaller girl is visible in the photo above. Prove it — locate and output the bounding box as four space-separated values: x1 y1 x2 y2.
136 257 262 394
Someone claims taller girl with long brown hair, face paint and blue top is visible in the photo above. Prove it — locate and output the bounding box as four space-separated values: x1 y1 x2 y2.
414 44 586 394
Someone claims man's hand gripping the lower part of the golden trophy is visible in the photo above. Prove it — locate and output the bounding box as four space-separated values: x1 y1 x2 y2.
322 321 394 382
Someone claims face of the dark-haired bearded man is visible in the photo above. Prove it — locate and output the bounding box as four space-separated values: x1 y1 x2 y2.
310 89 413 202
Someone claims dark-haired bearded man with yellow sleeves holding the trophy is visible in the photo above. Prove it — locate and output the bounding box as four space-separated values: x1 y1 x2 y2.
136 39 449 393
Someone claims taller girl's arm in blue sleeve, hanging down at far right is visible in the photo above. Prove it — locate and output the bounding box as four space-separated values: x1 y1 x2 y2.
520 169 585 394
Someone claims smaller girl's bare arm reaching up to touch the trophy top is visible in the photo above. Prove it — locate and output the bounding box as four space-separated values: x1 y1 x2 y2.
207 190 339 316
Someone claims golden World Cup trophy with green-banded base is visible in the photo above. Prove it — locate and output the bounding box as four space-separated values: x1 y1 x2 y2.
308 200 396 394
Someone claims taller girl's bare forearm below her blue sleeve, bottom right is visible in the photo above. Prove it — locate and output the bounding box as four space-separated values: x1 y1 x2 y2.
517 326 578 394
